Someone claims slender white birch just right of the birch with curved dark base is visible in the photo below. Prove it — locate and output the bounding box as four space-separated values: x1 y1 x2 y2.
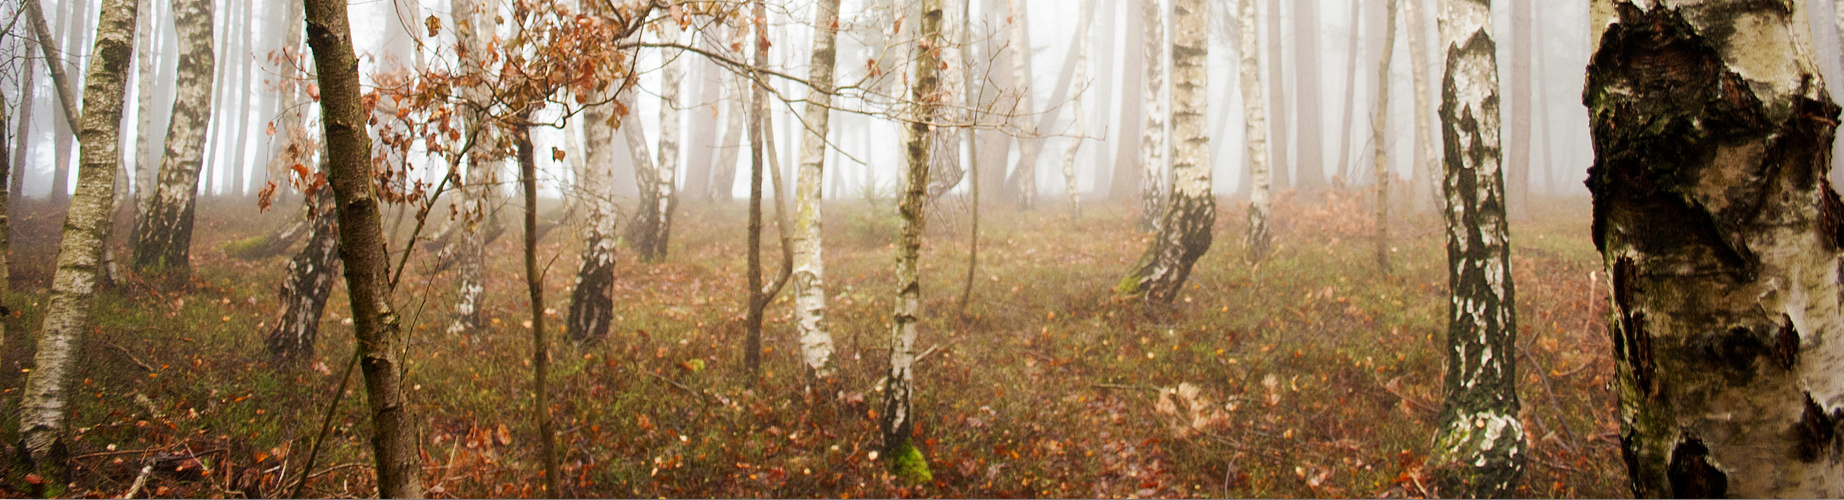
1235 0 1274 262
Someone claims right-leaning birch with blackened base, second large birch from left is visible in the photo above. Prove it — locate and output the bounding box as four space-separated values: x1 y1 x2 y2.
135 0 218 277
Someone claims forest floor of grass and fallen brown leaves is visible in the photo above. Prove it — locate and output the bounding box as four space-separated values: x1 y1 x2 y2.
0 192 1630 498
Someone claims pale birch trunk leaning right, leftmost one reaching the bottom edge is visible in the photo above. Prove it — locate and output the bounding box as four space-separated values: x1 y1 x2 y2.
18 0 136 496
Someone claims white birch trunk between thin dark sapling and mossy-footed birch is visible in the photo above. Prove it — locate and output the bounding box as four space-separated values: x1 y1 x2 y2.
793 0 839 382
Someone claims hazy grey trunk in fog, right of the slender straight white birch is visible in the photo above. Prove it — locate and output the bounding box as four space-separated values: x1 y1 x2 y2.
1293 0 1326 192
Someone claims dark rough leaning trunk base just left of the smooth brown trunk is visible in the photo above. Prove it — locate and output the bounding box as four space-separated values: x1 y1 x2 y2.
266 188 339 363
